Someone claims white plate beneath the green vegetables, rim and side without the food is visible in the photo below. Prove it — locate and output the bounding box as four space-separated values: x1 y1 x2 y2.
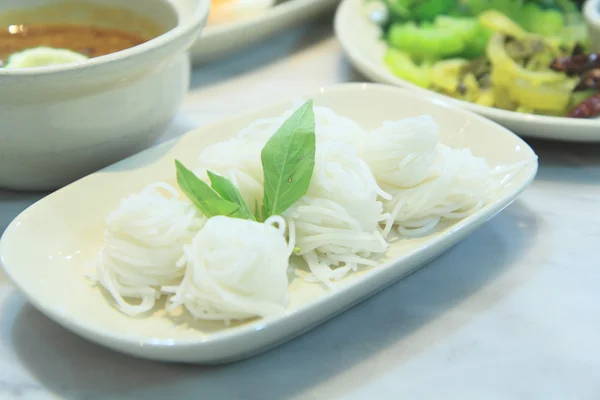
335 0 600 142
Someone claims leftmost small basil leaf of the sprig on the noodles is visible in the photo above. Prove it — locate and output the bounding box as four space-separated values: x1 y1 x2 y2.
175 160 240 218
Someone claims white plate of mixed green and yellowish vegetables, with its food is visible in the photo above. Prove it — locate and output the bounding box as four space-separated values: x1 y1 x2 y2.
335 0 600 142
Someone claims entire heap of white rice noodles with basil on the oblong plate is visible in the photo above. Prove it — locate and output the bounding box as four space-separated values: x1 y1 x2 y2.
89 103 529 323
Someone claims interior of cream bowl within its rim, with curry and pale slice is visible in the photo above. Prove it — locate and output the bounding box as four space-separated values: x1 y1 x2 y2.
0 2 176 68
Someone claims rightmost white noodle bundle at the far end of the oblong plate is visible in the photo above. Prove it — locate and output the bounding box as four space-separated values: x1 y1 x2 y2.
363 115 499 236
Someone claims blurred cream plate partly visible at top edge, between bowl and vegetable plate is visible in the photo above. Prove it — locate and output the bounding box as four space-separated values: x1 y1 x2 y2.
190 0 340 63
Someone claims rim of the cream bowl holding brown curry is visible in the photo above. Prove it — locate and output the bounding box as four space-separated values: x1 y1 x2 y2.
0 0 211 78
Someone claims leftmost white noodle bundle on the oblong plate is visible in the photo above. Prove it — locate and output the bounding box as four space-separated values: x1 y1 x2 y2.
96 182 204 315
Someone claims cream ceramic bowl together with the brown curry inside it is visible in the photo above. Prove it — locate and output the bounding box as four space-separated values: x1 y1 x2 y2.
0 0 210 190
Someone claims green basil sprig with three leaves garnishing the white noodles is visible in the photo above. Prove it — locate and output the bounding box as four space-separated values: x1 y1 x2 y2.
175 100 316 222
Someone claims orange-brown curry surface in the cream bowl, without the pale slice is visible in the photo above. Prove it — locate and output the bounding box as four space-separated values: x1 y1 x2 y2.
0 24 150 66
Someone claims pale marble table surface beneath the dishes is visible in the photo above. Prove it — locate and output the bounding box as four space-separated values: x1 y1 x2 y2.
0 17 600 400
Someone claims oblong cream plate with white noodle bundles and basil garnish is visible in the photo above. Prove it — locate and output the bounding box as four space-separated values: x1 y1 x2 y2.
0 84 537 363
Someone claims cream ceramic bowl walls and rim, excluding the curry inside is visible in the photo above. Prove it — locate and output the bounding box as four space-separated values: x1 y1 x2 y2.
0 0 210 190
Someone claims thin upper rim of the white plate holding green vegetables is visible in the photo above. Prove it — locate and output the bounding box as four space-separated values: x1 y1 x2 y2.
334 0 600 131
